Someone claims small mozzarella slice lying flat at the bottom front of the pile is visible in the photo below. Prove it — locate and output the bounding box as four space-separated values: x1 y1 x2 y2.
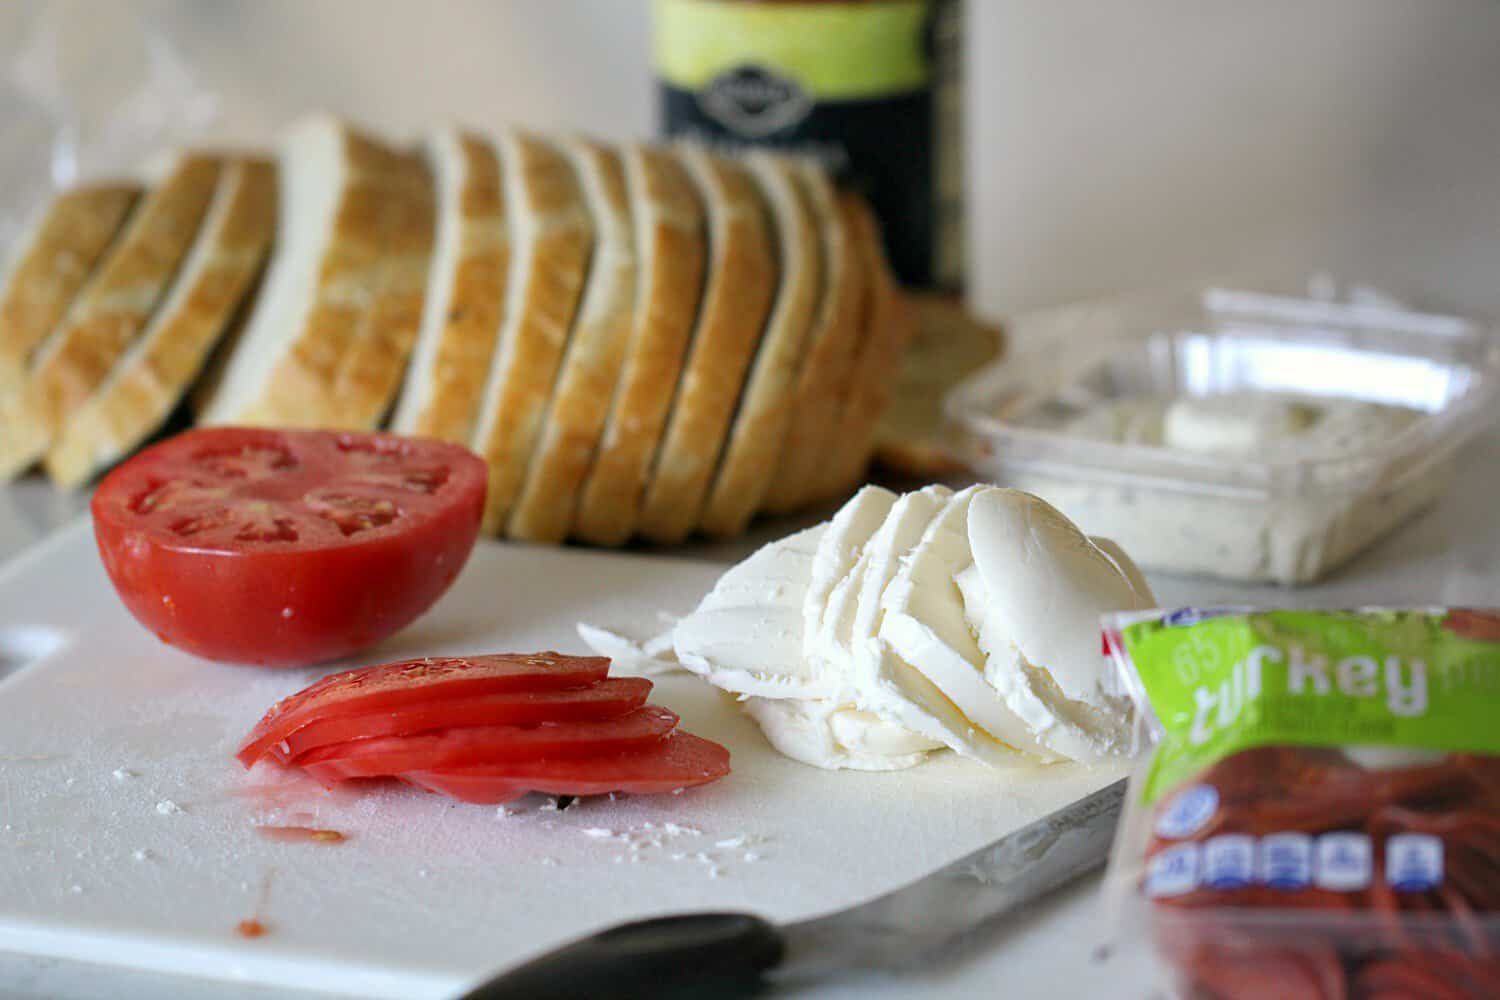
744 697 942 771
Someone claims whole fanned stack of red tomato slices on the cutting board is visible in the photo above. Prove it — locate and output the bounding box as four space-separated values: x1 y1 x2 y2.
237 652 729 804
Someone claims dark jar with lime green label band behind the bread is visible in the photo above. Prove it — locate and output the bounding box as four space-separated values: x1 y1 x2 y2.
653 0 963 291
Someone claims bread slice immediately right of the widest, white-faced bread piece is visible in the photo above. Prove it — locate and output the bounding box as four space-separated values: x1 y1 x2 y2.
392 129 510 444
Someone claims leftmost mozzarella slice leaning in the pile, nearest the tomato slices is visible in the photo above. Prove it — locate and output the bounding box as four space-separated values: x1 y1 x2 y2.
672 525 836 699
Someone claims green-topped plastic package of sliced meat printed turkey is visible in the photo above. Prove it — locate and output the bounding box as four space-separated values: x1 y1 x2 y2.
1106 609 1500 1000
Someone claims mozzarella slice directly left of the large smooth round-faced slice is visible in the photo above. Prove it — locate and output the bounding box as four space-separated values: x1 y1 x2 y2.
878 486 1058 760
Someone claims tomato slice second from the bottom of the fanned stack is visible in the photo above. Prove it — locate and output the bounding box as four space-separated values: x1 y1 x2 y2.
297 705 677 784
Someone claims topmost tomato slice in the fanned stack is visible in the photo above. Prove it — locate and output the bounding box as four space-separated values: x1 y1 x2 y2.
237 652 609 768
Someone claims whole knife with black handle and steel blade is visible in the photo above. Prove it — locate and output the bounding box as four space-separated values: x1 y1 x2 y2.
461 778 1125 1000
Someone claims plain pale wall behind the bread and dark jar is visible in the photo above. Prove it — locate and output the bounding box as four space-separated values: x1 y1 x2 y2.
0 0 1500 316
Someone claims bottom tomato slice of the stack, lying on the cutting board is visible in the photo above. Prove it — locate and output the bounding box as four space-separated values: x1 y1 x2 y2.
401 732 729 805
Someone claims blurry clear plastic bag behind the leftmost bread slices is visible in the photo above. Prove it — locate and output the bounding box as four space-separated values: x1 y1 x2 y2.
0 0 218 248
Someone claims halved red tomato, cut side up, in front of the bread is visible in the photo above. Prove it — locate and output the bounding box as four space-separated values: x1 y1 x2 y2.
93 427 486 667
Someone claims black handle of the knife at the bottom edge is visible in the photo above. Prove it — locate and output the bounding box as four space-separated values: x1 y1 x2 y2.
461 913 786 1000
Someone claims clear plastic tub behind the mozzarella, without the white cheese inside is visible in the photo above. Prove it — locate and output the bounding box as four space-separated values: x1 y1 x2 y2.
945 289 1500 585
